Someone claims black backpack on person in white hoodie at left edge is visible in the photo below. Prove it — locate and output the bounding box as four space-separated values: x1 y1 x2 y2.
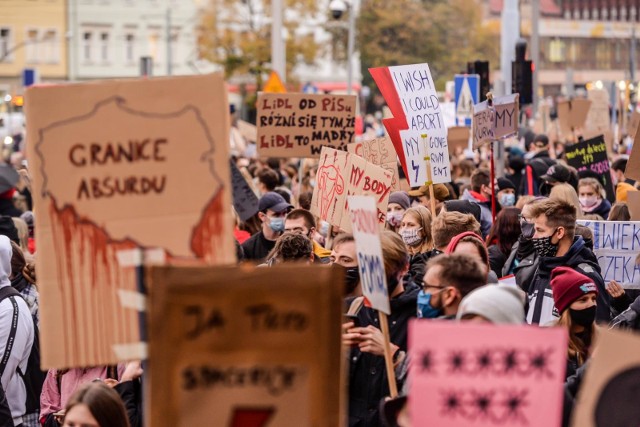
0 286 47 414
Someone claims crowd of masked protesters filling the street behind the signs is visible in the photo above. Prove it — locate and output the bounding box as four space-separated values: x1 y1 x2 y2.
0 108 640 427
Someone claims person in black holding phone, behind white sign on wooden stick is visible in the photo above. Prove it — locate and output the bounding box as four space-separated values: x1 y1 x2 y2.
342 234 420 427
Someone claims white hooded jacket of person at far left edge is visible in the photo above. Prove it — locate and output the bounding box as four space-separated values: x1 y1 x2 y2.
0 236 34 425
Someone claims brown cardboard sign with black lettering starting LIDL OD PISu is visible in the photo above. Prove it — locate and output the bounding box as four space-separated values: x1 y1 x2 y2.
257 93 356 158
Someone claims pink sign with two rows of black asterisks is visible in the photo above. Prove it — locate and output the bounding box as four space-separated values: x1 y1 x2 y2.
409 320 567 427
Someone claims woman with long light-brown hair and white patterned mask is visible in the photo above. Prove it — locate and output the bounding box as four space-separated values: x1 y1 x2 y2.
399 206 435 283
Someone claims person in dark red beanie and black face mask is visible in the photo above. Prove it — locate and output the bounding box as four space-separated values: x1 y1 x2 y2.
551 267 598 378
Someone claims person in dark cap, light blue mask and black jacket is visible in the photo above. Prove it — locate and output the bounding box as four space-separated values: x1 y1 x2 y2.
242 192 293 262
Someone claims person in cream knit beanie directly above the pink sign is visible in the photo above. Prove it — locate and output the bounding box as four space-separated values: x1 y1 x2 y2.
456 285 526 325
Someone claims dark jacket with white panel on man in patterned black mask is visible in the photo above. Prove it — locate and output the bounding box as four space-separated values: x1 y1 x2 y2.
515 236 611 325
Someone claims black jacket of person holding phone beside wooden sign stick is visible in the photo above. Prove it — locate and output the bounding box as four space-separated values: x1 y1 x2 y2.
349 282 420 427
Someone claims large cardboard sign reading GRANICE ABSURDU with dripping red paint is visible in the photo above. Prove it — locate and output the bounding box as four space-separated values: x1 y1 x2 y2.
26 74 235 368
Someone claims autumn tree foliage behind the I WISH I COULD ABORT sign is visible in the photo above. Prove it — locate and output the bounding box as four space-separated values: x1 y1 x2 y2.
358 0 500 90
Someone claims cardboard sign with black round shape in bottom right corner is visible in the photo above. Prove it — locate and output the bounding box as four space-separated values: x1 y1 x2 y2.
571 328 640 427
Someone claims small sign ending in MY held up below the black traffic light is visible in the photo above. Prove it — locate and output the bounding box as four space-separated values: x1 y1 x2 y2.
473 93 520 149
